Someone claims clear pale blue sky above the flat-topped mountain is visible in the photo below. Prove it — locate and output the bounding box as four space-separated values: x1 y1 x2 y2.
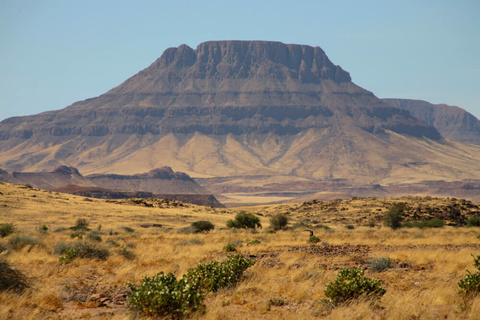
0 0 480 120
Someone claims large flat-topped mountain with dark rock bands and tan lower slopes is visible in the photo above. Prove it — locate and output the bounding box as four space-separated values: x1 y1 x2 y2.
0 41 480 199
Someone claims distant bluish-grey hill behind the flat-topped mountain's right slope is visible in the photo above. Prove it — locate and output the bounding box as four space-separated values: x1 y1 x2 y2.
382 99 480 145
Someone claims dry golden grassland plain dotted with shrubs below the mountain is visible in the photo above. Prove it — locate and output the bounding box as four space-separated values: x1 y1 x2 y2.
0 183 480 319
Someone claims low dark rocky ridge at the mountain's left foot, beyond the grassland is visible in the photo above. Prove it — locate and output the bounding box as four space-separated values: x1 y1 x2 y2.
0 166 223 207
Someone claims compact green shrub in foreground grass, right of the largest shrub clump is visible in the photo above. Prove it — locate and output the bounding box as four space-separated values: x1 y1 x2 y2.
325 269 386 305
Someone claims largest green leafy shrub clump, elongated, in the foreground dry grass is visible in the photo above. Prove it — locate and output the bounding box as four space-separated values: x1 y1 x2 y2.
127 255 254 319
